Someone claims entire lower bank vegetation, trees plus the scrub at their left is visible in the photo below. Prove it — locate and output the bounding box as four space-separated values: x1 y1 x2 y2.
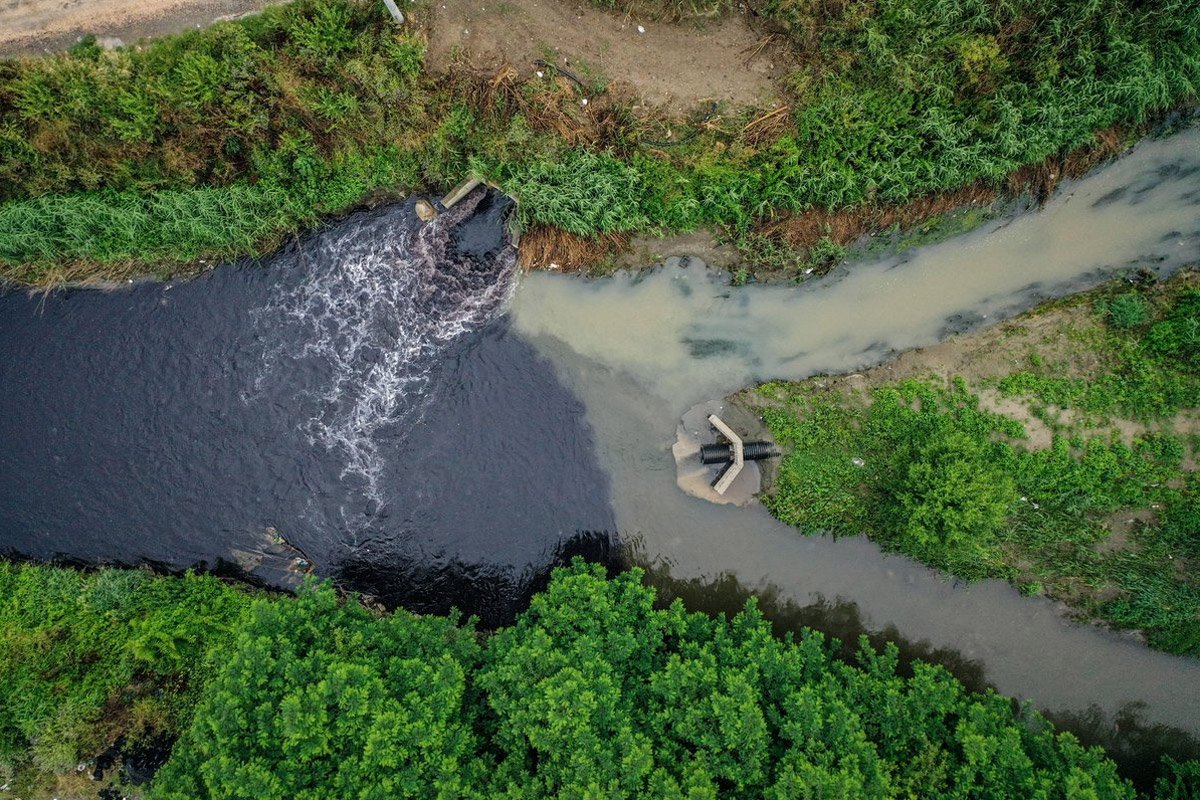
0 564 1200 800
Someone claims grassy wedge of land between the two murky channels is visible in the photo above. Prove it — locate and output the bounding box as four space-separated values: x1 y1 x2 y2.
744 276 1200 656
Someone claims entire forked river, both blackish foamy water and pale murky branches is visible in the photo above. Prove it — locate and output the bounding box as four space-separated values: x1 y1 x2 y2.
0 123 1200 777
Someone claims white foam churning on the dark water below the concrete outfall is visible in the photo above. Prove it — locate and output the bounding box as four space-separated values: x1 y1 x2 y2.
254 192 516 511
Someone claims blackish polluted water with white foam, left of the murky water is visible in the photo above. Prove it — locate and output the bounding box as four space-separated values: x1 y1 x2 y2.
0 192 616 625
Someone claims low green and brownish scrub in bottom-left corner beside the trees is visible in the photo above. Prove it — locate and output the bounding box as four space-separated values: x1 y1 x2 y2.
0 561 251 796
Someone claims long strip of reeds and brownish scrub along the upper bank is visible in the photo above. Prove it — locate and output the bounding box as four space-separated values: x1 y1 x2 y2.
0 0 1200 283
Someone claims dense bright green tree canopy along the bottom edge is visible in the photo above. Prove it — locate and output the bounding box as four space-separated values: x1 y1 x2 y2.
150 563 1134 800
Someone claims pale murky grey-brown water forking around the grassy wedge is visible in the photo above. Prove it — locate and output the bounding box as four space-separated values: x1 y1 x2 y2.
512 128 1200 734
